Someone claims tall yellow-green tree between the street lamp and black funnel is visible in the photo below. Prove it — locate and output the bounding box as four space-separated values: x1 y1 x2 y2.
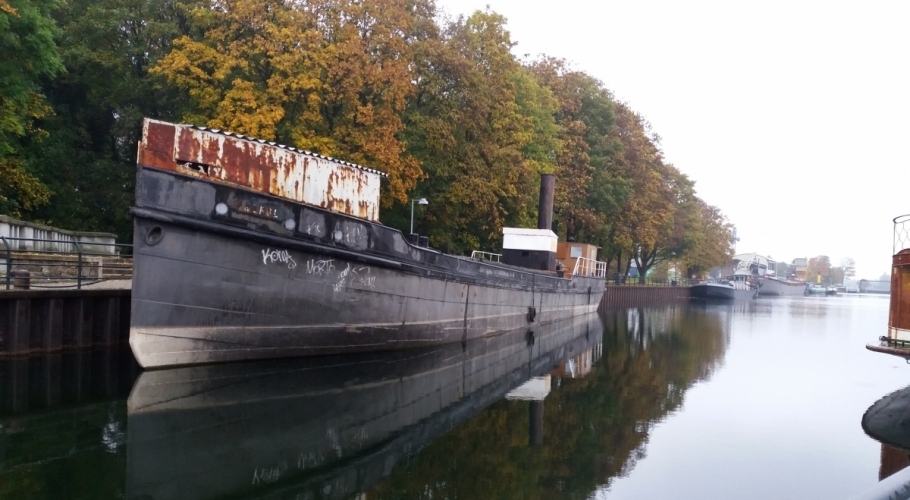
402 12 559 253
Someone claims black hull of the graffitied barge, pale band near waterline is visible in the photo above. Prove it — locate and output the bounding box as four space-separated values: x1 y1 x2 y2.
130 167 604 368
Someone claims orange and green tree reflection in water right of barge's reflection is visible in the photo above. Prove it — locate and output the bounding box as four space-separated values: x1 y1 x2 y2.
366 305 734 500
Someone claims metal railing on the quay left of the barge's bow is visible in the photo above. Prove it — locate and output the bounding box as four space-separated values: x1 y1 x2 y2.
0 236 133 290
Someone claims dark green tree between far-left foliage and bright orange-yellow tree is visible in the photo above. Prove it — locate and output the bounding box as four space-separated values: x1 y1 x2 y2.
12 0 205 239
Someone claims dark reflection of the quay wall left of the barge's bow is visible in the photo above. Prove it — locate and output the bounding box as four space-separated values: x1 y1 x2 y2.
0 349 140 499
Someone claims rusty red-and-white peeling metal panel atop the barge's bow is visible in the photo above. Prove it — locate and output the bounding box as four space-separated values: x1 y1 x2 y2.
137 120 385 221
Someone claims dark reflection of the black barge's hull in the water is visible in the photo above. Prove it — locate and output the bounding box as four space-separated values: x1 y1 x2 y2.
127 314 603 499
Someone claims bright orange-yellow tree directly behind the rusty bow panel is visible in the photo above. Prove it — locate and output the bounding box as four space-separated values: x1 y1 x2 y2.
153 0 433 204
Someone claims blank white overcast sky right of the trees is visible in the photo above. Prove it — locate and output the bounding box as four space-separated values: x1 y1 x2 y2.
437 0 910 279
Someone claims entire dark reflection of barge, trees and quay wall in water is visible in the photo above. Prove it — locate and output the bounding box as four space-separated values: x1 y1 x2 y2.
0 304 732 500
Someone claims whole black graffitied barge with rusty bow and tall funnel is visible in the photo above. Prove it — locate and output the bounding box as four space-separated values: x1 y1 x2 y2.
130 120 605 368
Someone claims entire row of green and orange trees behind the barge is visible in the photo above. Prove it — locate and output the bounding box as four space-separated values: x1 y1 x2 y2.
0 0 730 271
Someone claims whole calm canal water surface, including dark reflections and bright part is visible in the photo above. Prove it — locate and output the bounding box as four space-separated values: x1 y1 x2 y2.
0 296 910 500
